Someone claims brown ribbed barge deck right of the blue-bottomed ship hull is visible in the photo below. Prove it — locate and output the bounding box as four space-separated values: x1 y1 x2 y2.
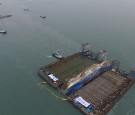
70 71 134 115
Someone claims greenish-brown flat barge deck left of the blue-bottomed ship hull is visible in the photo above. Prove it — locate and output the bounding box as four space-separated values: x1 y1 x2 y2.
38 53 96 88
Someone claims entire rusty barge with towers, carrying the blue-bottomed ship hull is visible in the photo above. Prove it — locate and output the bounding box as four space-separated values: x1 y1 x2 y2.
38 43 135 115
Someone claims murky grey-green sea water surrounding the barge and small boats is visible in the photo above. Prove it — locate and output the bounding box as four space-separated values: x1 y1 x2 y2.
0 0 135 115
